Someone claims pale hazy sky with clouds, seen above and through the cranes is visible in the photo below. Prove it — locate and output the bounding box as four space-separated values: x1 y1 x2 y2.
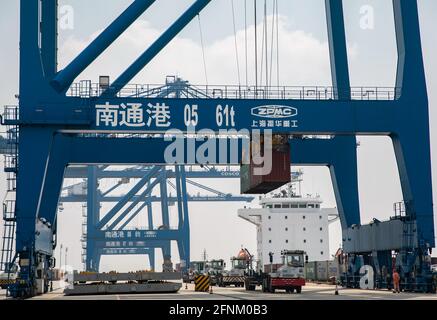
0 0 437 271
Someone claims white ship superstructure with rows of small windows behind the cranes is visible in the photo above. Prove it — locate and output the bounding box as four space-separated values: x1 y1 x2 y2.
238 172 338 267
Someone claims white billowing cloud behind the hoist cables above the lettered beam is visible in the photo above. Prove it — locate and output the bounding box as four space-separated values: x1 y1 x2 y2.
60 17 338 85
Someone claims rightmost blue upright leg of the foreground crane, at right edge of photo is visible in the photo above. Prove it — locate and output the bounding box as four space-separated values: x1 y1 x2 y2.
391 0 435 247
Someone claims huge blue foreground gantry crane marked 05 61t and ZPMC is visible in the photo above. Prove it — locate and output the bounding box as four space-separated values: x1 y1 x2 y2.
2 0 435 297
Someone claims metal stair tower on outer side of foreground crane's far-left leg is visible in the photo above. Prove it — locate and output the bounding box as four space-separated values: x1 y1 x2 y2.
0 106 19 273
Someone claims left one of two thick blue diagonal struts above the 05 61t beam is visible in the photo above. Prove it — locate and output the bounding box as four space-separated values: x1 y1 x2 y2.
50 0 156 92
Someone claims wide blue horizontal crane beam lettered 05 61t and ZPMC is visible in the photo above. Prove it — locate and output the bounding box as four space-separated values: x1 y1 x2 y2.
20 96 403 136
